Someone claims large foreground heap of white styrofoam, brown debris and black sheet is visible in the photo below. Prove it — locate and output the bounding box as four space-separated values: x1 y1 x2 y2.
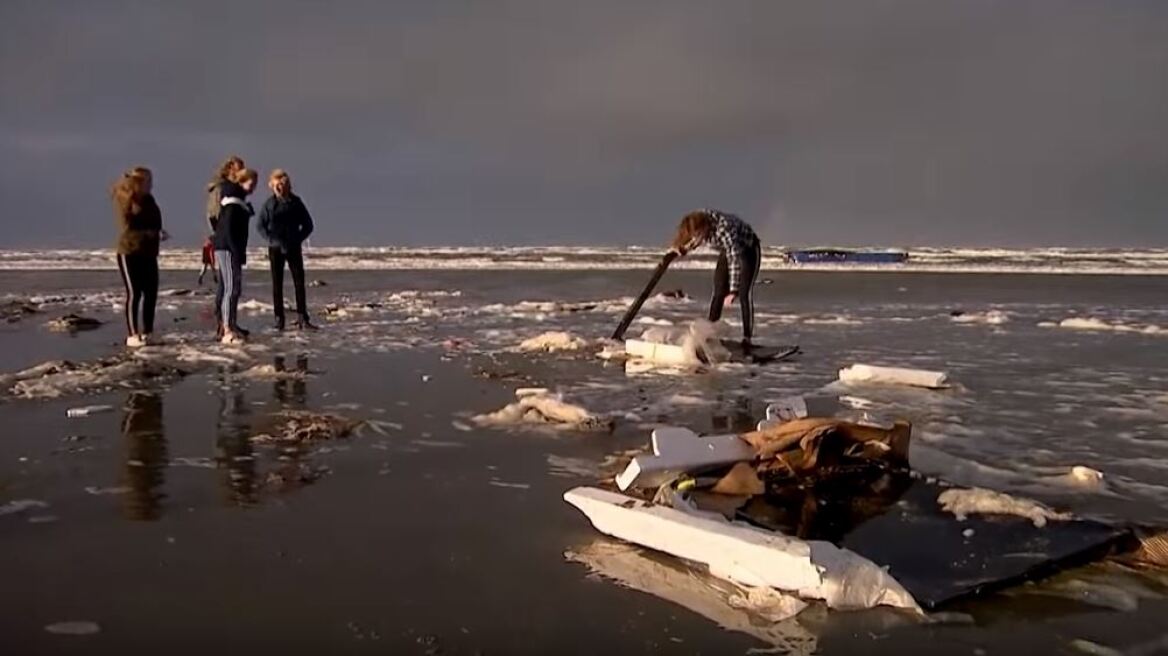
564 396 1168 614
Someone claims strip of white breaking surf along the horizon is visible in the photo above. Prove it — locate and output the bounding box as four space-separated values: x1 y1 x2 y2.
0 246 1168 275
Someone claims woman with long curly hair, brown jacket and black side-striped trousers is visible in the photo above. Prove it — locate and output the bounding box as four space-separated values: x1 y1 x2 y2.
111 167 169 348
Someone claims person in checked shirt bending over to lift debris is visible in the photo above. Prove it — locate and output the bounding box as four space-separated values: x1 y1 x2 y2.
673 209 763 347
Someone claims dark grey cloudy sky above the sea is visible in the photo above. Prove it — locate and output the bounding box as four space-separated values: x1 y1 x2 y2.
0 0 1168 249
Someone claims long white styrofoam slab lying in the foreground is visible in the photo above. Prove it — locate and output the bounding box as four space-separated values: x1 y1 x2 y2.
564 488 919 610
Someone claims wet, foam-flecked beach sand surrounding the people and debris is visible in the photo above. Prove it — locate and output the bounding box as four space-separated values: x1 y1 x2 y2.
0 270 1168 654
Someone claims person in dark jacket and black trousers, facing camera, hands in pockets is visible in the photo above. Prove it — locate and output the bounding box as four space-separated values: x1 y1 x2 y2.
258 168 317 330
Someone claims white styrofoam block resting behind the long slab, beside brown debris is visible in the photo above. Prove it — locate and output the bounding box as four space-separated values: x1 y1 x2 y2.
617 426 757 490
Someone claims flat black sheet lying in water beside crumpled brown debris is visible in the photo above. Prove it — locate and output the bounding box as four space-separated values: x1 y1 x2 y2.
738 463 1132 609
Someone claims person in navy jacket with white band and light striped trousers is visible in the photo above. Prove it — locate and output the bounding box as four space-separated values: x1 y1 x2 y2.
211 168 257 344
